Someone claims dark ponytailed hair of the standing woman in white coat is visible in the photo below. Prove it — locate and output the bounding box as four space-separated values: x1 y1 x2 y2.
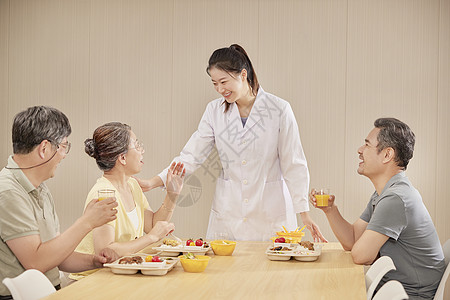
206 44 259 112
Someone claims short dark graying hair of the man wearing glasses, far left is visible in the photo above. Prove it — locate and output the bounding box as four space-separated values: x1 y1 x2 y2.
12 106 72 154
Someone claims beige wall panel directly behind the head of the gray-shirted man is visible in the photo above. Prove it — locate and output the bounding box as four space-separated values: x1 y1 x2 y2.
345 1 439 225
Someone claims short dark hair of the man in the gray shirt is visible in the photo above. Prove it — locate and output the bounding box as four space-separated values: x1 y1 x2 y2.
374 118 416 170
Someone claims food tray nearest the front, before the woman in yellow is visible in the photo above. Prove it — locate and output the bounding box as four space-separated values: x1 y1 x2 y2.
103 253 180 276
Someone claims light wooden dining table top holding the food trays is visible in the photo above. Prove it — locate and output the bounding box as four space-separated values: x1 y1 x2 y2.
45 241 366 300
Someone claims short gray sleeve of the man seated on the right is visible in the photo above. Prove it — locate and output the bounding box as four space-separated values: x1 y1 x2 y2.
367 195 407 240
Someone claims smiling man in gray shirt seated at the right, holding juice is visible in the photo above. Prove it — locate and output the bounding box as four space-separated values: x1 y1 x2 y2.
310 118 445 299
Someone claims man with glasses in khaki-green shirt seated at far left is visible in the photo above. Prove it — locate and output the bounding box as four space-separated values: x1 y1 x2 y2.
0 106 117 299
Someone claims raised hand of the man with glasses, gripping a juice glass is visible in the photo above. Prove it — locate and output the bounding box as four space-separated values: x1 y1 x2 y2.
82 198 118 229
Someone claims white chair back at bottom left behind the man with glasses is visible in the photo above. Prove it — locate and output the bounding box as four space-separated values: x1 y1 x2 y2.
3 269 56 300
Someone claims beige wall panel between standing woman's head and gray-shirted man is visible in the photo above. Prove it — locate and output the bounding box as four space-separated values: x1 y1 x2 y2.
258 1 347 238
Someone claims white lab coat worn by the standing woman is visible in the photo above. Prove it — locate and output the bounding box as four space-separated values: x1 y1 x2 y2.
159 87 309 240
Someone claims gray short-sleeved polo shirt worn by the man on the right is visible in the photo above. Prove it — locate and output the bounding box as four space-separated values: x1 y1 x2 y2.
360 172 445 299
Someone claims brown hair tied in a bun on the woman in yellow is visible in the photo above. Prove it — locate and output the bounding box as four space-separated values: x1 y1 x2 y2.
84 122 131 171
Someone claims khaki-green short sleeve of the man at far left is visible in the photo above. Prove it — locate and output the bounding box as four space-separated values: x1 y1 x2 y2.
0 190 39 241
